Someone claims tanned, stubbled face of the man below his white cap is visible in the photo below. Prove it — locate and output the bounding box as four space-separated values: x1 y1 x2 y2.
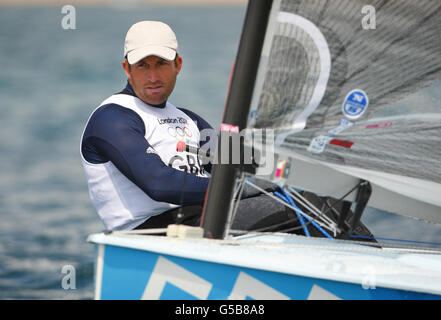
123 56 182 104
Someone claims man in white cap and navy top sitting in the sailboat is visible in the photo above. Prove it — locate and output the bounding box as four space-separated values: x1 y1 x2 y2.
81 21 374 240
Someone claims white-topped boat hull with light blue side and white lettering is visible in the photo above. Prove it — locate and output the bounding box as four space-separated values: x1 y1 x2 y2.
88 233 441 300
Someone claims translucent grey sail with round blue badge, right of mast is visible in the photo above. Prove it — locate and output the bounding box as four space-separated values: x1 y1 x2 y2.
248 0 441 218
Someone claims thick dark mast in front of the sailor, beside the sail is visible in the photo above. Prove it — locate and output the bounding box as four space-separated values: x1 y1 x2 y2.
202 0 272 239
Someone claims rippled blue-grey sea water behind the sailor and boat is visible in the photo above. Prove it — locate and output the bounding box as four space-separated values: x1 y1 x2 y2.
0 6 441 299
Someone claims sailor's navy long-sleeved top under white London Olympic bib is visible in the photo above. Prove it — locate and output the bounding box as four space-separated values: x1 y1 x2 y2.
81 84 211 230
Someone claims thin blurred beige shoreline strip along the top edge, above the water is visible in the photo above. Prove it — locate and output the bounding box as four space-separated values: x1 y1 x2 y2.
0 0 248 6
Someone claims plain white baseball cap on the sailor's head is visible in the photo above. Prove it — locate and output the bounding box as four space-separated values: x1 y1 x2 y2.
124 21 178 64
